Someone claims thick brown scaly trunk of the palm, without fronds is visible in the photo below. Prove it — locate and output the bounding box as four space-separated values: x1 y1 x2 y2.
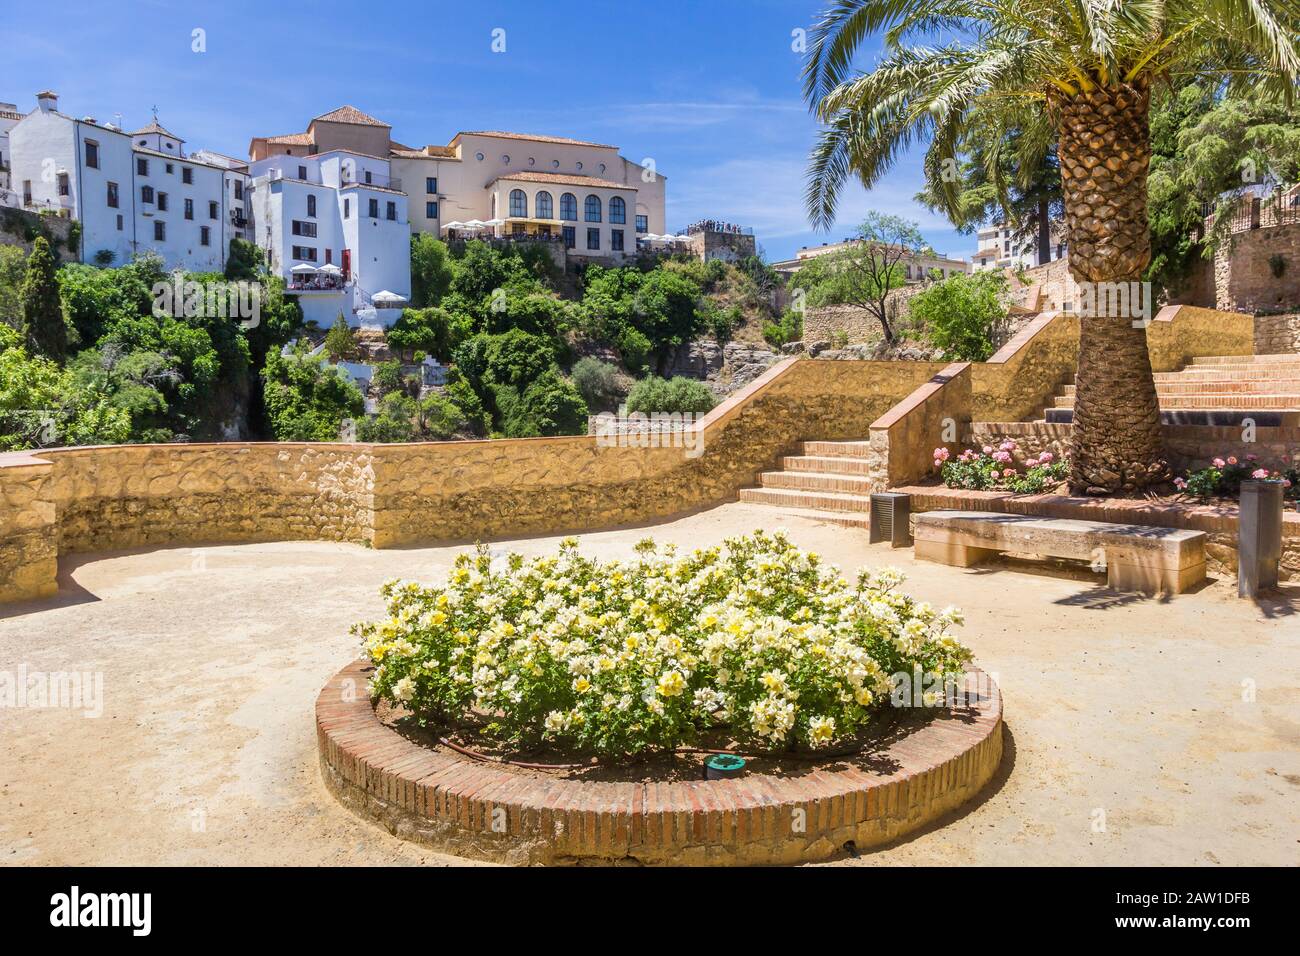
1050 82 1170 494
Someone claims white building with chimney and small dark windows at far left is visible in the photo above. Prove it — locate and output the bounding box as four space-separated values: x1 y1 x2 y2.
9 91 247 272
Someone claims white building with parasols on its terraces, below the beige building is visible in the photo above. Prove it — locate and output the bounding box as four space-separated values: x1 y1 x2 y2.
248 150 411 328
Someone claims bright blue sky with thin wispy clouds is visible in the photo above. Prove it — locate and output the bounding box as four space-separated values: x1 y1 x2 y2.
0 0 975 260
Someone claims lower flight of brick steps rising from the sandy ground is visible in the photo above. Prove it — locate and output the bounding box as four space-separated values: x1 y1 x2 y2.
740 441 879 528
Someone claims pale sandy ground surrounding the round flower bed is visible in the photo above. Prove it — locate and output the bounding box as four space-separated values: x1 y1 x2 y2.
0 505 1300 865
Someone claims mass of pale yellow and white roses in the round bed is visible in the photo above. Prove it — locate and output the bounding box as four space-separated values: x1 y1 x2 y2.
354 532 971 756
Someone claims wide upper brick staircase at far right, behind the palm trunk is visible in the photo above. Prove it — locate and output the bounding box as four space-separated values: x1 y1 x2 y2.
1043 354 1300 425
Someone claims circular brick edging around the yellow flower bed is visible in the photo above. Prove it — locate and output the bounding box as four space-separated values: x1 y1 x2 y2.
316 659 1002 865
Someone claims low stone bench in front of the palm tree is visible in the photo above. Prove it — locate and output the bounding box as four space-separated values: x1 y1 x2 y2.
913 511 1205 594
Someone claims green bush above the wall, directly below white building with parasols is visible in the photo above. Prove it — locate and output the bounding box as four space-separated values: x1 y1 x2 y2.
264 342 365 441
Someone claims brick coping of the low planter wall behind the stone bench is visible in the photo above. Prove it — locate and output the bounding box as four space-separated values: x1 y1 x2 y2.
889 485 1300 538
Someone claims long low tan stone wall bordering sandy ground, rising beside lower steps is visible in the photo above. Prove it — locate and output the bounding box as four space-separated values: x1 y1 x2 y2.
0 359 943 600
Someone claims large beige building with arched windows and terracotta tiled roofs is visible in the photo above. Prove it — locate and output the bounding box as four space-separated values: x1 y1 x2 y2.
248 107 667 259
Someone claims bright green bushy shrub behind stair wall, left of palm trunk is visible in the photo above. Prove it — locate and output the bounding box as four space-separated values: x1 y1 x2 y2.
907 271 1008 362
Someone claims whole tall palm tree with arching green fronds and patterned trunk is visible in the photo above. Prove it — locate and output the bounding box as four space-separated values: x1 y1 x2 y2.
803 0 1300 494
